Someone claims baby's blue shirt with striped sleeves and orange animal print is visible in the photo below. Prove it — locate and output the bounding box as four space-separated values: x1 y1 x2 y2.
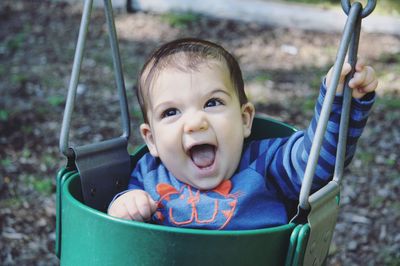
128 82 375 230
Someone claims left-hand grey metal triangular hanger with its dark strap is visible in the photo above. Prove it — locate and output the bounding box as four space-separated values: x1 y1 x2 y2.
60 0 130 211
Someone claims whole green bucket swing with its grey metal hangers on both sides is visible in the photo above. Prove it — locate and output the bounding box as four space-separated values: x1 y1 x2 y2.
56 0 376 266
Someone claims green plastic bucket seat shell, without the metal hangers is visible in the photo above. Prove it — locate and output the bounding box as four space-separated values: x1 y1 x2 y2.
57 117 312 265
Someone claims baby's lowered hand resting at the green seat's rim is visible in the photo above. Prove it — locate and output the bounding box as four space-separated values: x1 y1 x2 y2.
108 189 157 222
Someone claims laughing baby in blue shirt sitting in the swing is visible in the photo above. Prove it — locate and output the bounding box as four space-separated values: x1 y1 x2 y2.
108 39 378 230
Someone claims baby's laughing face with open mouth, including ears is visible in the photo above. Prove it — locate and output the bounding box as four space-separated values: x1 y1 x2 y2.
140 61 254 190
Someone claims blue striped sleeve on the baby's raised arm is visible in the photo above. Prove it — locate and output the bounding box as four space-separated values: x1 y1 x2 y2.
266 82 375 200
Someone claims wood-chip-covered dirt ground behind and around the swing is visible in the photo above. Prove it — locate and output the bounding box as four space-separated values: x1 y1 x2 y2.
0 0 400 265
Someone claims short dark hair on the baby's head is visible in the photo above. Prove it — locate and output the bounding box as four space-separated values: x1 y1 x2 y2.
136 38 247 122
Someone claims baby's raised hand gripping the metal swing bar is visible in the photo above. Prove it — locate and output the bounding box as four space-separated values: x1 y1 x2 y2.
326 61 378 99
